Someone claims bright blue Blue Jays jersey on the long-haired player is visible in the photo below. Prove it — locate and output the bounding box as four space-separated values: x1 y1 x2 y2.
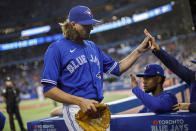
41 38 119 101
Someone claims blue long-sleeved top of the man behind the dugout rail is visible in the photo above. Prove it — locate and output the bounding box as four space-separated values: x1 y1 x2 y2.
132 86 177 113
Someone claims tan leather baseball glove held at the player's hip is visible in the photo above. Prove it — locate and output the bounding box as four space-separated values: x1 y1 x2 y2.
75 103 111 131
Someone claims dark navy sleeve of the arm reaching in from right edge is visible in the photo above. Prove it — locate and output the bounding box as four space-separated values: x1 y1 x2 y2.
153 49 196 103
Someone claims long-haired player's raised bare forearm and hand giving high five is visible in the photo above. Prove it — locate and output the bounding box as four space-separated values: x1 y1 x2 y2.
119 33 151 75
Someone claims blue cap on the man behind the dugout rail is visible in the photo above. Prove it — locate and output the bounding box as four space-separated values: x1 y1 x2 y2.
136 64 165 77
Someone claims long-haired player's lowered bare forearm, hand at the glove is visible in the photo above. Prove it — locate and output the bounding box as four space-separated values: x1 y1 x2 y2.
44 87 98 112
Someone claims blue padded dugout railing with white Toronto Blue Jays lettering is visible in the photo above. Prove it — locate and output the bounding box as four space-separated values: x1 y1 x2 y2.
27 84 196 131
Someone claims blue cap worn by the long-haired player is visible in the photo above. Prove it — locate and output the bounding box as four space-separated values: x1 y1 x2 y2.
68 5 100 25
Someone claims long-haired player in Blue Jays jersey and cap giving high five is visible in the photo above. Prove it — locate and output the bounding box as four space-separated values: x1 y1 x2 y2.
41 6 149 131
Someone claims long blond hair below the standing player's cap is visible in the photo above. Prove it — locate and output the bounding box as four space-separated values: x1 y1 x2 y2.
59 20 80 40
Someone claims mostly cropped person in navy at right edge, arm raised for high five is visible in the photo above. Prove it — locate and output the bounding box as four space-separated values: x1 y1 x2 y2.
144 30 196 110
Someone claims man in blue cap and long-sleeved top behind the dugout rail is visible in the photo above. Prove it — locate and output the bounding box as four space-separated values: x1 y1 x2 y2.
131 64 177 113
